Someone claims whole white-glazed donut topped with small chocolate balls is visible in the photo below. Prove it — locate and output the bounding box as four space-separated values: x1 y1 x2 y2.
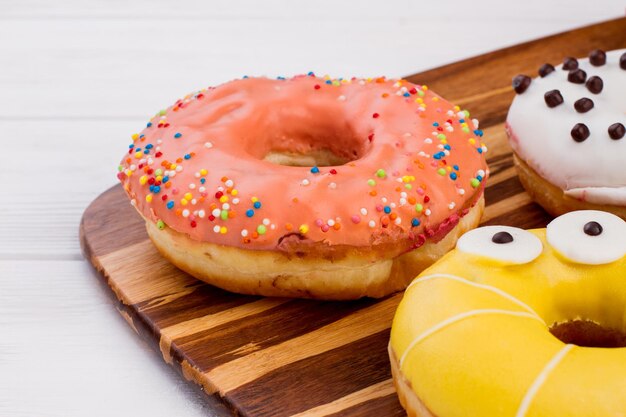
507 49 626 217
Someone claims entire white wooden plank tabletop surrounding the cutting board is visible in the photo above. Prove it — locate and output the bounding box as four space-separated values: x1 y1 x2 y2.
0 0 626 417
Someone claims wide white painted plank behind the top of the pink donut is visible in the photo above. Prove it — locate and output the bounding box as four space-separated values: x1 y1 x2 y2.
0 0 624 119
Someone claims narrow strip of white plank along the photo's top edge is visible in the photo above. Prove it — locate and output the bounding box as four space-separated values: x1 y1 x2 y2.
0 0 624 21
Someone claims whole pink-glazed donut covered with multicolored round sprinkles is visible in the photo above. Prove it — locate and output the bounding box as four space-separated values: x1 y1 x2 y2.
118 73 489 300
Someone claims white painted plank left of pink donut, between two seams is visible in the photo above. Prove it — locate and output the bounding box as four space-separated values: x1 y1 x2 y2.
0 120 136 259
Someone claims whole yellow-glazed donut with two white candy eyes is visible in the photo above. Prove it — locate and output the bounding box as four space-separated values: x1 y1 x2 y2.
389 210 626 417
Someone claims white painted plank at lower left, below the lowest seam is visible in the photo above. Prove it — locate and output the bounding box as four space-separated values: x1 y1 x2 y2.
0 261 211 417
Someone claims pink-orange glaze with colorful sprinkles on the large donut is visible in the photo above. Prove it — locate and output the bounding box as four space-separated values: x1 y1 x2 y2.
118 76 487 250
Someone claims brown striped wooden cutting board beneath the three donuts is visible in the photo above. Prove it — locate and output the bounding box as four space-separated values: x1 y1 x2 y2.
80 18 626 417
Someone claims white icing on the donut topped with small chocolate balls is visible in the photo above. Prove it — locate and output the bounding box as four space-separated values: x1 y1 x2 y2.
507 49 626 206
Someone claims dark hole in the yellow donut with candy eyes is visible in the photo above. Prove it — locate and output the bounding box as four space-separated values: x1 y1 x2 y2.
550 320 626 348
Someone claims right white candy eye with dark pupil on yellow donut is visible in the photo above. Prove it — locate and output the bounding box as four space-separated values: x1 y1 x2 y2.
546 210 626 265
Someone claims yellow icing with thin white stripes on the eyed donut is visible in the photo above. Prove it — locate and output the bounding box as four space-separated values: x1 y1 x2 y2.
391 229 626 417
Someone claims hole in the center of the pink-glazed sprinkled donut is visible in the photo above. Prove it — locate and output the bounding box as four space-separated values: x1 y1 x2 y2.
248 103 371 167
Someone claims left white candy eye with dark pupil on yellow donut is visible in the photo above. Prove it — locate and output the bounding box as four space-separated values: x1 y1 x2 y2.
456 226 543 264
